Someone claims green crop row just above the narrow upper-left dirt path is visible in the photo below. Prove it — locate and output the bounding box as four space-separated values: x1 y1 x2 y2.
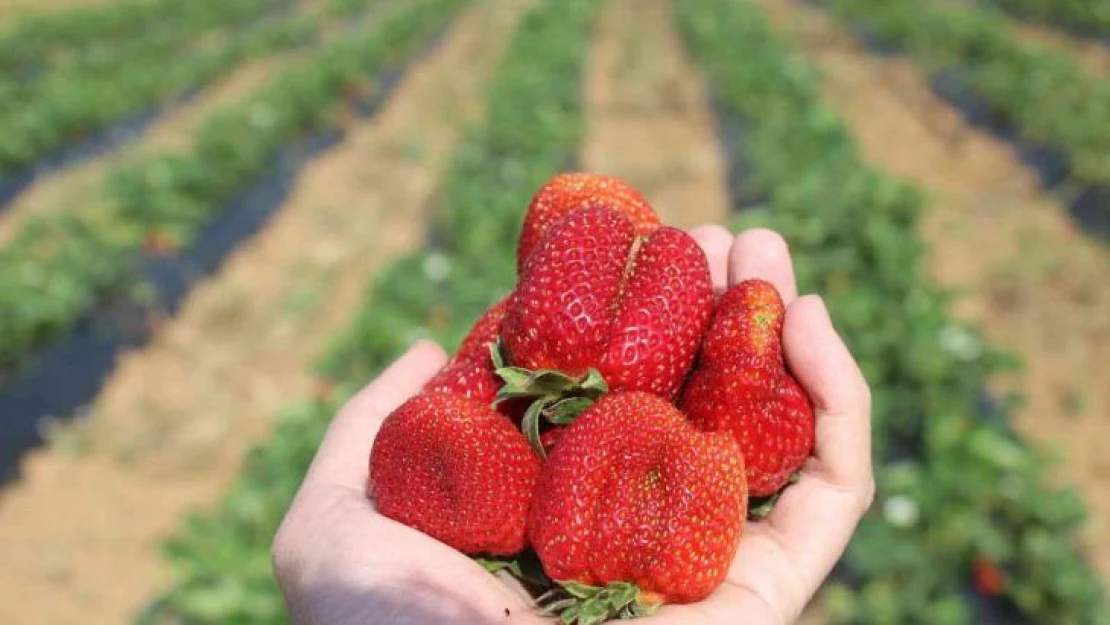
0 0 359 173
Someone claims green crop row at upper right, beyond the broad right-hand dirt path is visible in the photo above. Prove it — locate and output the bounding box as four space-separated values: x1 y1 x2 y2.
828 0 1110 195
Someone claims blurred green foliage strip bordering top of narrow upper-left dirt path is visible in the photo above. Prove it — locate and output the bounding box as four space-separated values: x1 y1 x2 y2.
0 0 346 170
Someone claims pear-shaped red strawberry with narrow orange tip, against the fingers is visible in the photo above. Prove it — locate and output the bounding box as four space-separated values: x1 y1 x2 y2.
679 280 814 496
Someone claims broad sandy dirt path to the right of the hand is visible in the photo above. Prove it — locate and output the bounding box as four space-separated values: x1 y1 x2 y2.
761 0 1110 578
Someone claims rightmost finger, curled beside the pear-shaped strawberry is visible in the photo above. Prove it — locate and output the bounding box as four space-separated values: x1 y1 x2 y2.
783 295 871 488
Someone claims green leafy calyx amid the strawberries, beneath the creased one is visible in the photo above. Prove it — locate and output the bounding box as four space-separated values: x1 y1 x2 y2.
490 342 609 460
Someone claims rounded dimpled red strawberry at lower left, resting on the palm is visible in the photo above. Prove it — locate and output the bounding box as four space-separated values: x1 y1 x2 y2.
367 393 539 555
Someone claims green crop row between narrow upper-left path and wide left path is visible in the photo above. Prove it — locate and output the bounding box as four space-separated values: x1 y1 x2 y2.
0 0 446 375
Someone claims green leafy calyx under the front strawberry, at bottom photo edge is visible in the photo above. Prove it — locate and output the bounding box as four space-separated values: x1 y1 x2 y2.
539 582 663 625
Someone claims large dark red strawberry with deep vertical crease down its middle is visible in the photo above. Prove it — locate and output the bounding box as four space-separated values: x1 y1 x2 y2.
502 209 713 399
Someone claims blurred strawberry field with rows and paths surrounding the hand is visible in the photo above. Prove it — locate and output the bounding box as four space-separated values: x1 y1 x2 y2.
0 0 1110 624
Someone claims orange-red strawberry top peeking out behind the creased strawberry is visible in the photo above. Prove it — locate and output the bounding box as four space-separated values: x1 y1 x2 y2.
516 173 659 270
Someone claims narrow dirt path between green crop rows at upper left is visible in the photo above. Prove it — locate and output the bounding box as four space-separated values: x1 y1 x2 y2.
0 0 333 246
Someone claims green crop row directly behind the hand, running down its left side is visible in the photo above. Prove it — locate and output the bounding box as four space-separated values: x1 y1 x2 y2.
137 0 597 624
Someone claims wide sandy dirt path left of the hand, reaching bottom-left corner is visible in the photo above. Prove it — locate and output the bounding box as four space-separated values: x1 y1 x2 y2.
0 0 527 624
